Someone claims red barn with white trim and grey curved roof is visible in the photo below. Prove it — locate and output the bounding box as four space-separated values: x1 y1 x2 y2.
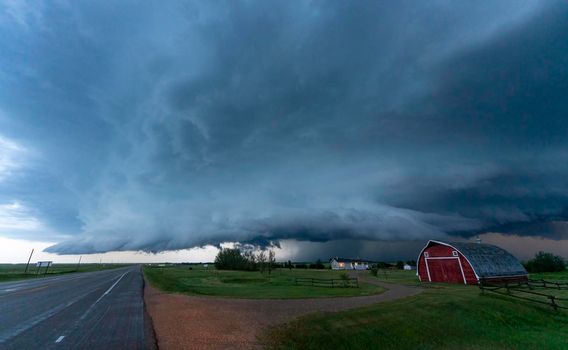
416 240 528 284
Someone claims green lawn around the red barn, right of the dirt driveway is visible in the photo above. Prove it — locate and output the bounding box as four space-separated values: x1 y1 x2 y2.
261 271 568 350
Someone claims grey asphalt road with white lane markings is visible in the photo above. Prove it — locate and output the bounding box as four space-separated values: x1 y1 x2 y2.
0 266 155 349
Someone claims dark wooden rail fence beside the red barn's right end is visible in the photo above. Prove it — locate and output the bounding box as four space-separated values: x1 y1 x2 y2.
479 280 568 310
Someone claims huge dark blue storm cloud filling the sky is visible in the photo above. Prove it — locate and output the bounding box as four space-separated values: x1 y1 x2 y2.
0 1 568 254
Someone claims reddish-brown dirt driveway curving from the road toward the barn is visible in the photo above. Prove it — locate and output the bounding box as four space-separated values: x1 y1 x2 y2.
145 275 421 350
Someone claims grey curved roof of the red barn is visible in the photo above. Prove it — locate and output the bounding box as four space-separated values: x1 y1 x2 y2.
428 241 527 278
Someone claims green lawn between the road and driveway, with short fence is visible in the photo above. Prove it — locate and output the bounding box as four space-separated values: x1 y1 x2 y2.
144 265 384 299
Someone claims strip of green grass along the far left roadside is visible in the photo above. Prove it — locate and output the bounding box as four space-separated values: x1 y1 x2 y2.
0 264 128 282
